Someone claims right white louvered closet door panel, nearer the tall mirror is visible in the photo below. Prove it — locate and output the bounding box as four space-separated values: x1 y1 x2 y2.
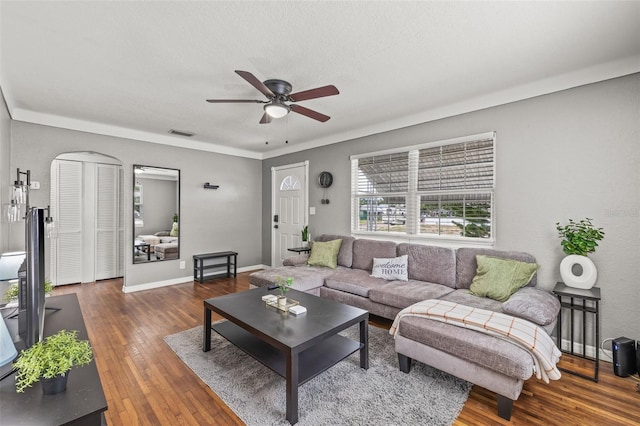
94 164 120 280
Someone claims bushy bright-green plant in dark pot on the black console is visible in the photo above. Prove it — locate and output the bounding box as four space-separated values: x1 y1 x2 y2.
13 330 93 395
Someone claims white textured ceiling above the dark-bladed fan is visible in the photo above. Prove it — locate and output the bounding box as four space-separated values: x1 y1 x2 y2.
0 0 640 158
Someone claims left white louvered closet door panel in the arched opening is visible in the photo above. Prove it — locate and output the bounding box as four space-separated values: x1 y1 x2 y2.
51 160 83 285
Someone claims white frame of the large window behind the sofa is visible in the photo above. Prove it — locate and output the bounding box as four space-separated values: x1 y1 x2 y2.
350 131 497 246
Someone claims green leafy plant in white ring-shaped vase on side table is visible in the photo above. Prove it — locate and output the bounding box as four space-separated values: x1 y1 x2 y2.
556 218 604 289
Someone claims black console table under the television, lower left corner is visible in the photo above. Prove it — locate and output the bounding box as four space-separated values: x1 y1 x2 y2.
0 294 107 425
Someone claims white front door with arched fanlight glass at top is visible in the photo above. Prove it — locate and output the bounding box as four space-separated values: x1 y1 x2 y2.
271 161 309 266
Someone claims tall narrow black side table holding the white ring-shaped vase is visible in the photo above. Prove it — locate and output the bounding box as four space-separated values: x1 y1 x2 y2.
553 282 601 382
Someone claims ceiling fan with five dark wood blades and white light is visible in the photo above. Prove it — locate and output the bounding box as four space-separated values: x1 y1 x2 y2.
207 70 340 124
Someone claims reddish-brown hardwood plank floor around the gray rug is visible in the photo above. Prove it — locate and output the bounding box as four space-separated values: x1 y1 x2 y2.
54 273 640 425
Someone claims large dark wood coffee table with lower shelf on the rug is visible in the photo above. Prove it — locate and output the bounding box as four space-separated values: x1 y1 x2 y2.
202 287 369 424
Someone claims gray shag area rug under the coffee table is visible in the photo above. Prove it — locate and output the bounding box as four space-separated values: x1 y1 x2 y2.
164 326 472 426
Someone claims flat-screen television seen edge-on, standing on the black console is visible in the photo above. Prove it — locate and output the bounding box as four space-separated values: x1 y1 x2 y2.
18 207 45 347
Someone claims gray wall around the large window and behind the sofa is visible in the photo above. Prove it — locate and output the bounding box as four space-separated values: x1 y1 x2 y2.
262 74 640 339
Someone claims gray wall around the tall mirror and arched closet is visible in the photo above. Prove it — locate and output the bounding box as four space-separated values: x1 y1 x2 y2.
3 121 262 287
